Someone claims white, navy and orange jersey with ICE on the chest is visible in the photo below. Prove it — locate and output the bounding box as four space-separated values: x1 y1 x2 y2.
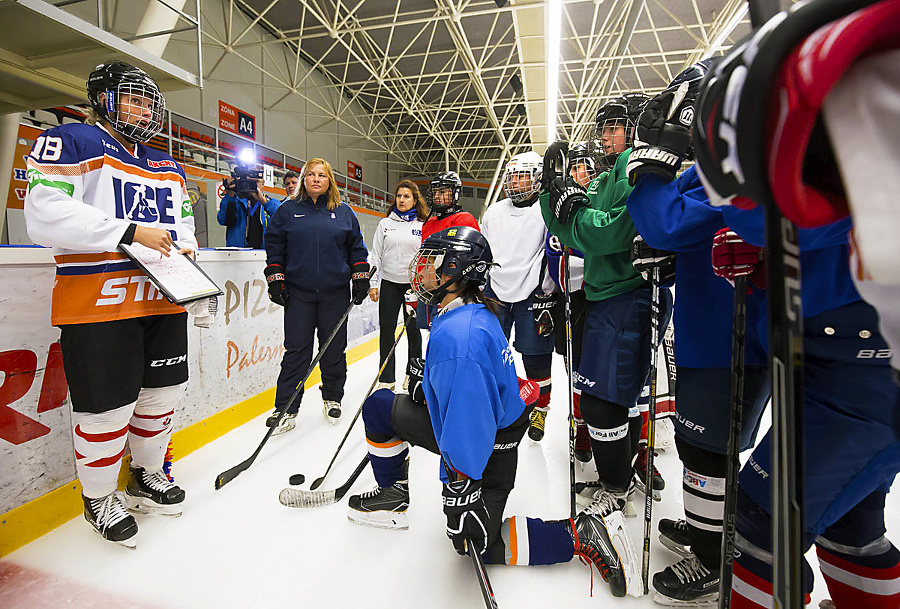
25 123 197 325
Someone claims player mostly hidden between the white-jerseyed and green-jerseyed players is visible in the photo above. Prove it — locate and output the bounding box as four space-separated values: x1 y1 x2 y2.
544 143 598 456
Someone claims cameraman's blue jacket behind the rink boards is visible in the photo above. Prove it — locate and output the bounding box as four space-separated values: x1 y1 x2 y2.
216 177 281 249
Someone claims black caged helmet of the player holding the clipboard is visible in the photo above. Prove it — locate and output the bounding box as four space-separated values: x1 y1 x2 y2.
87 60 166 143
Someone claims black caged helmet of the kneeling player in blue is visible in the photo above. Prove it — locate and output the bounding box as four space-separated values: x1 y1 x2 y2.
409 226 494 304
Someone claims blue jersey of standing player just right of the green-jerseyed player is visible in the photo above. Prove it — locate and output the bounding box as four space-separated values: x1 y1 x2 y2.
626 167 766 368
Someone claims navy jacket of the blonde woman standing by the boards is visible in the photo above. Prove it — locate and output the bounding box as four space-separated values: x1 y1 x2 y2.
265 195 369 292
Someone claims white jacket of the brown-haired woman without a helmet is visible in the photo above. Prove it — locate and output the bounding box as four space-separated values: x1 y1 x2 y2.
369 210 422 288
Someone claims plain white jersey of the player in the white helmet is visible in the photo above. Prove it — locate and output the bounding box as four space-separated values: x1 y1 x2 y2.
481 199 547 303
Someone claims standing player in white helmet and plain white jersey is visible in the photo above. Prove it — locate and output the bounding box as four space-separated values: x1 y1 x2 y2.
481 151 554 442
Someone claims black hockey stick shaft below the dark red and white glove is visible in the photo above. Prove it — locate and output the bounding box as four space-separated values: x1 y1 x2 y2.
719 275 747 609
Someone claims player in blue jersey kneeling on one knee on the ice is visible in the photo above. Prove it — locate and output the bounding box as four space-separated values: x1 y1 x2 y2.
348 227 640 596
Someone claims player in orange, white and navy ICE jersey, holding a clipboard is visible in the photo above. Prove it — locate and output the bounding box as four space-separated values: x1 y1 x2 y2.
25 61 211 547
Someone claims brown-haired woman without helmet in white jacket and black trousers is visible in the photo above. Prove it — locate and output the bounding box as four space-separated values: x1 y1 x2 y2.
369 180 428 391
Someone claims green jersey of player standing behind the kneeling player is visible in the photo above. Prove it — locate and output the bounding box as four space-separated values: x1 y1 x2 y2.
540 148 647 300
